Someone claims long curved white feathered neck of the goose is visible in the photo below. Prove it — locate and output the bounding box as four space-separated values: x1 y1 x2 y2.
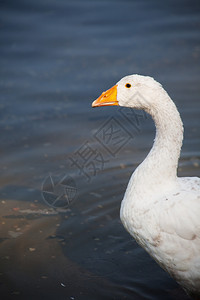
127 91 183 197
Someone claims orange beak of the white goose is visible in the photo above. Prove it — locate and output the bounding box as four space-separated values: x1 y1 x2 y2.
92 85 119 107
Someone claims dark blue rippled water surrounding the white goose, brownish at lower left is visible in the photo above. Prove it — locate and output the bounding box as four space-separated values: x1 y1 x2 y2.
0 0 200 300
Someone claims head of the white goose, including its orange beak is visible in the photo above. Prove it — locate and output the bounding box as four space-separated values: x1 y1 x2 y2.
92 75 164 111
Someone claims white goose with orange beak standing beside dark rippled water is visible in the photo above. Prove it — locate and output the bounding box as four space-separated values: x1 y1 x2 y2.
92 75 200 299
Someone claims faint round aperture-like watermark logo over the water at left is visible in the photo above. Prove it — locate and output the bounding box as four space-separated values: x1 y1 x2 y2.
42 174 77 208
